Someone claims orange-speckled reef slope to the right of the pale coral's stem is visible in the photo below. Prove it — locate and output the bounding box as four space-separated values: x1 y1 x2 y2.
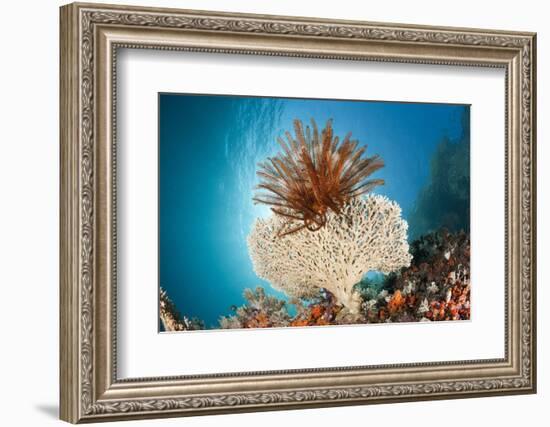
358 229 470 323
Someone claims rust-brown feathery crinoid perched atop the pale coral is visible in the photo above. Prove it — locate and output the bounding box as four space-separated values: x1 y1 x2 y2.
253 119 384 236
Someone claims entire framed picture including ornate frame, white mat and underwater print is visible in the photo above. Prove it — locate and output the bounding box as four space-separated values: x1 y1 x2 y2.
60 4 536 423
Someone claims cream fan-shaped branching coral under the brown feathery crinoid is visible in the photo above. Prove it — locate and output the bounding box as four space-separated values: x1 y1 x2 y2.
248 195 411 313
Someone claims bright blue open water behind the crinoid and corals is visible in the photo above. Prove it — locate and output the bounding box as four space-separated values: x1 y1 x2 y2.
159 94 469 327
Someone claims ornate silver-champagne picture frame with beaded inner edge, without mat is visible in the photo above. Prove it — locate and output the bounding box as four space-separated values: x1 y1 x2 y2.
60 3 536 423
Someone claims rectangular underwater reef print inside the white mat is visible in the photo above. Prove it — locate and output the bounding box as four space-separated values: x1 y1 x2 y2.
158 93 470 333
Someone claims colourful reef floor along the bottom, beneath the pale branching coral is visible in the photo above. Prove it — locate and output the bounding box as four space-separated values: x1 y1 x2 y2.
161 230 470 331
